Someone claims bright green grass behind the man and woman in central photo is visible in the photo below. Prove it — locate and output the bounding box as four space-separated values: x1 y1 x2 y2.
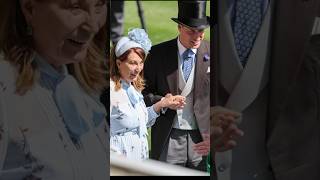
124 1 210 45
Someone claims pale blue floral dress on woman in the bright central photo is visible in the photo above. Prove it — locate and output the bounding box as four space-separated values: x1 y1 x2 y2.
110 80 159 160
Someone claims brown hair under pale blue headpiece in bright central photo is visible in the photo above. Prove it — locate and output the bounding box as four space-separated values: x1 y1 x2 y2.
110 45 146 91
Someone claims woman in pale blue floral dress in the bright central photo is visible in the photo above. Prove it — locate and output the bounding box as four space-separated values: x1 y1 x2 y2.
110 29 185 160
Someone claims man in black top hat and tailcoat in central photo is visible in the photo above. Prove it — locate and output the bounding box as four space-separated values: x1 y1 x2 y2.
143 1 210 170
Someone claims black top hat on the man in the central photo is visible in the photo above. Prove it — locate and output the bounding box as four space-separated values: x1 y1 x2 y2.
171 0 210 29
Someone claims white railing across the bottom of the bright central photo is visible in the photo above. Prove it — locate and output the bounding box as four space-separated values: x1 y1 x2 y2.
110 153 209 176
